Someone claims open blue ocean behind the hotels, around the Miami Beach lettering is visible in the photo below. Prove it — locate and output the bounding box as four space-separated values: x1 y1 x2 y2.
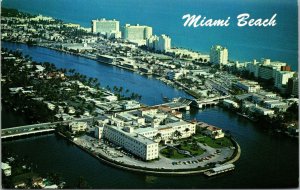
2 0 298 70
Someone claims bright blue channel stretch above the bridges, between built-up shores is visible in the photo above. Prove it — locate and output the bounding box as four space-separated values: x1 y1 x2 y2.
2 42 192 105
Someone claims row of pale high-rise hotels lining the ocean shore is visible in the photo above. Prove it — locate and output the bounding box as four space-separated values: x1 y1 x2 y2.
5 15 298 96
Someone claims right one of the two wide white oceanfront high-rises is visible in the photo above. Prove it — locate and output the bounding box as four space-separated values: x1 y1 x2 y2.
122 24 152 41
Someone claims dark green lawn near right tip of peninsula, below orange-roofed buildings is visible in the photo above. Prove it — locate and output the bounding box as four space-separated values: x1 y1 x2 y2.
193 134 234 148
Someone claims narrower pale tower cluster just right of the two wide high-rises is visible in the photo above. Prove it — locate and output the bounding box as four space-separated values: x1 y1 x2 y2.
147 34 171 52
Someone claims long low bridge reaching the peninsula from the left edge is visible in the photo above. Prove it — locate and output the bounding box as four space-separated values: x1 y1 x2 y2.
1 117 100 139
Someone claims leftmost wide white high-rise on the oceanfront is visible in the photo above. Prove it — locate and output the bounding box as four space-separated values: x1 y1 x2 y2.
92 18 121 38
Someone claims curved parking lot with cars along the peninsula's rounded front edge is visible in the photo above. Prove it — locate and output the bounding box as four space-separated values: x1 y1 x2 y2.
74 135 234 169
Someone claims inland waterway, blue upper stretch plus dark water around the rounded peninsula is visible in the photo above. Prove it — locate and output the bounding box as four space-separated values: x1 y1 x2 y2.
2 42 299 188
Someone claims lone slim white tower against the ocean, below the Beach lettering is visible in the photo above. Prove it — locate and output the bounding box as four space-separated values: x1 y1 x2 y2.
210 45 228 65
